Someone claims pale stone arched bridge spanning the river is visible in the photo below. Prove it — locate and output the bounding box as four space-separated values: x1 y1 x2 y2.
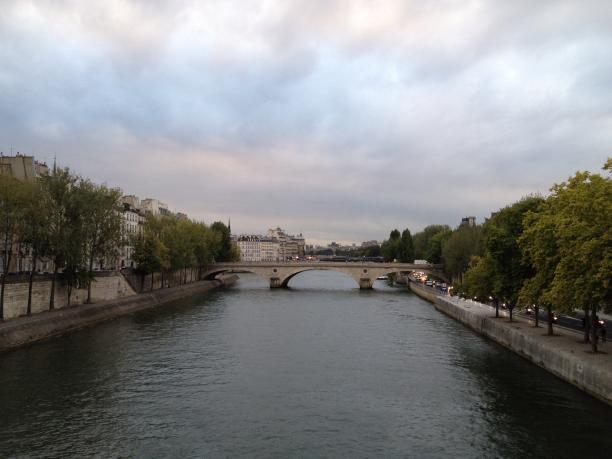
201 261 446 290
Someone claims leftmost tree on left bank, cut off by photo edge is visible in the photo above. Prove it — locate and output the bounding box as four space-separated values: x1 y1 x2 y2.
0 174 26 320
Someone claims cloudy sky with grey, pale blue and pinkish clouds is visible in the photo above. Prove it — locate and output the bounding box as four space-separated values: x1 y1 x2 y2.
0 0 612 242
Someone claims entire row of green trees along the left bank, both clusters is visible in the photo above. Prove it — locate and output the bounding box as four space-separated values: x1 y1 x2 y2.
0 167 236 320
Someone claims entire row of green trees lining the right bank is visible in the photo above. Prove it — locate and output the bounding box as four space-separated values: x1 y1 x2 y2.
381 159 612 352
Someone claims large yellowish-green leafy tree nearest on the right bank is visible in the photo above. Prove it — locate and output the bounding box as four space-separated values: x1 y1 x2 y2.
521 165 612 352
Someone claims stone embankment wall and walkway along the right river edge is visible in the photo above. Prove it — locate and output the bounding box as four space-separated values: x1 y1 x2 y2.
409 282 612 406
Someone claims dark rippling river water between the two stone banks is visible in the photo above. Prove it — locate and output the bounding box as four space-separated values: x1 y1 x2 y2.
0 271 612 458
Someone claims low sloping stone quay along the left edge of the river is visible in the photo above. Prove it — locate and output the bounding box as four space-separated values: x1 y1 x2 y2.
0 275 238 352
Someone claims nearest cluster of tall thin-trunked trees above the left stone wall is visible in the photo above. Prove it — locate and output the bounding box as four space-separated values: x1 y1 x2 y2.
0 168 122 319
